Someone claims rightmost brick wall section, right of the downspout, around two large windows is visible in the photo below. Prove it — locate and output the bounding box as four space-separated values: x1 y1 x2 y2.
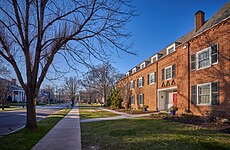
187 19 230 116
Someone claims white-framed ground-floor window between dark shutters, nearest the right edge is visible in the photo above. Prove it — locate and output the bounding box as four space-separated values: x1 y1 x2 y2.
198 83 211 104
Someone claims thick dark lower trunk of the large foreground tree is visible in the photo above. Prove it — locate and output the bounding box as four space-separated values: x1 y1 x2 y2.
26 93 37 129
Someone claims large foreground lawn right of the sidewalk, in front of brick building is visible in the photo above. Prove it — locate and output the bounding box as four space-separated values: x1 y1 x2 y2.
81 118 230 150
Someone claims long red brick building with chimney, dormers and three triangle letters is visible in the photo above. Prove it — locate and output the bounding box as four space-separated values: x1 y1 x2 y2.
117 2 230 116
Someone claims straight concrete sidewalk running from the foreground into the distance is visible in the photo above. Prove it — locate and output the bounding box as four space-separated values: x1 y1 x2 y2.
32 108 81 150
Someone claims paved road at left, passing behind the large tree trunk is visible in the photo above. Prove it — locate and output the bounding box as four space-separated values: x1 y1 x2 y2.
0 104 69 136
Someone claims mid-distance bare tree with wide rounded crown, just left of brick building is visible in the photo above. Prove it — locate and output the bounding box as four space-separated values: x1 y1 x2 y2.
82 63 122 106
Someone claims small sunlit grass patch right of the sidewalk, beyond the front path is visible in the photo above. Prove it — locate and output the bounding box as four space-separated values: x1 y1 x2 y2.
80 108 118 119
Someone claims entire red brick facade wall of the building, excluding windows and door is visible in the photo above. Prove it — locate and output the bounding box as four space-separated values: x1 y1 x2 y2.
118 19 230 116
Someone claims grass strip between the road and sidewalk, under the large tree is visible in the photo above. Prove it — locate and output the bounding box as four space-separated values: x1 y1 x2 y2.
0 109 71 150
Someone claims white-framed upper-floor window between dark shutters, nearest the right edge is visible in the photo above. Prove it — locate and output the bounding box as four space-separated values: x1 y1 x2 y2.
198 49 211 69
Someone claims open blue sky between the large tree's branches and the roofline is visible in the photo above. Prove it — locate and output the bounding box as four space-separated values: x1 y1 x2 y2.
113 0 228 73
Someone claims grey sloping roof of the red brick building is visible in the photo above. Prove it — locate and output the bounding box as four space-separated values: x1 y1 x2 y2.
128 2 230 72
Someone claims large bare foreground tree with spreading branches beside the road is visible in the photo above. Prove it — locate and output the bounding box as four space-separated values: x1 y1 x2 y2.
0 0 134 129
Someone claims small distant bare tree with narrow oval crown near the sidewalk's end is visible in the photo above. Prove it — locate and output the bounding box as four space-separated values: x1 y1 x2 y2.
64 76 80 106
